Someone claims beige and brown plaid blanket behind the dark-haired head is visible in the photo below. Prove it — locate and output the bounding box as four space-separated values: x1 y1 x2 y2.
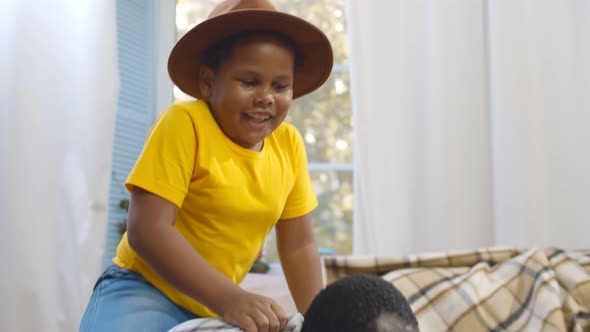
323 248 590 332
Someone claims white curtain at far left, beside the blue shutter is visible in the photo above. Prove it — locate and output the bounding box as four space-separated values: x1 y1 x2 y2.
0 0 119 332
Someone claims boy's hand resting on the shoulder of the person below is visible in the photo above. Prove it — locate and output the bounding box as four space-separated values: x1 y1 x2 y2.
221 290 287 332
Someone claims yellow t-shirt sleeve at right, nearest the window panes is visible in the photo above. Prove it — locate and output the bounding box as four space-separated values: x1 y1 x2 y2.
280 129 318 219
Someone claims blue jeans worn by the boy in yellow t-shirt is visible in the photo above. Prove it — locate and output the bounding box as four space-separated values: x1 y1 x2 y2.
80 265 198 332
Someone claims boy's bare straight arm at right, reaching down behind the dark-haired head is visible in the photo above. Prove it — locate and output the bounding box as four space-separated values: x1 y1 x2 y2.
276 214 322 314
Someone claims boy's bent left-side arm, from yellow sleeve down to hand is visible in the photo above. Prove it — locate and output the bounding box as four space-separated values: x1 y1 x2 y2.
127 187 286 332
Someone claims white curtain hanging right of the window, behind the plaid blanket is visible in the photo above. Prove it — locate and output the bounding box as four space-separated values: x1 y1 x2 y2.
348 0 590 255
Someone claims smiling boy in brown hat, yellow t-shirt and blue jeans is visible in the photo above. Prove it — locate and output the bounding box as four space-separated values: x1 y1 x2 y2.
81 0 332 332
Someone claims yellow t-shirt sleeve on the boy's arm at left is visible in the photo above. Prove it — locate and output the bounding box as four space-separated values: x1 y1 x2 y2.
125 106 198 208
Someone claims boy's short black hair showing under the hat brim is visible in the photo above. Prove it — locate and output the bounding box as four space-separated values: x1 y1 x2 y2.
202 30 303 72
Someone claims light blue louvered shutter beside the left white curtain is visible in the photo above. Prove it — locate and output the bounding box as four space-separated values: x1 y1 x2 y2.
103 0 156 266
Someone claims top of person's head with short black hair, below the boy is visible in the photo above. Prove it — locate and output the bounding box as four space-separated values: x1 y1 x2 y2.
301 274 419 332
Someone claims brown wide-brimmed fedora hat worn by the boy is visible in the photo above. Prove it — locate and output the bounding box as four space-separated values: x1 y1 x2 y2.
168 0 334 99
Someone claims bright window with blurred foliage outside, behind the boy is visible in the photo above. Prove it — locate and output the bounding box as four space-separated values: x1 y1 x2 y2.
174 0 353 261
